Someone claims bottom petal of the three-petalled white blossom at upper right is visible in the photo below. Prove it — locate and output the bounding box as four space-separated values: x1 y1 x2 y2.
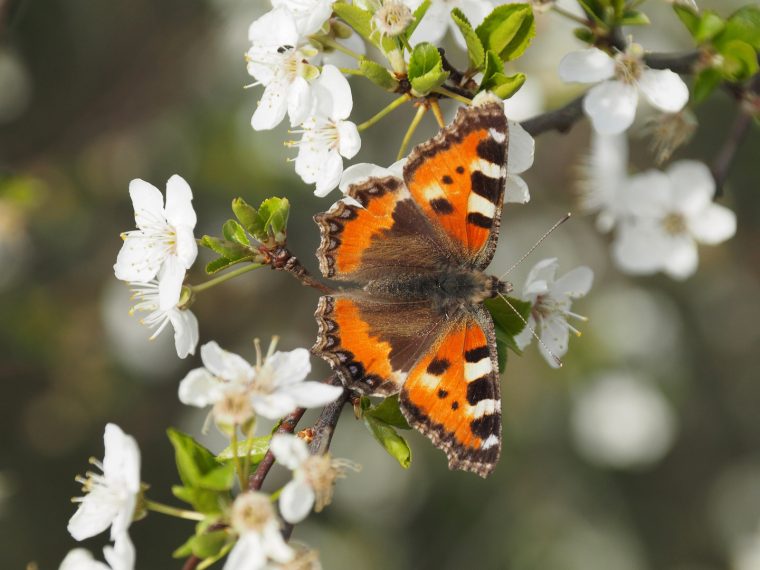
583 81 639 135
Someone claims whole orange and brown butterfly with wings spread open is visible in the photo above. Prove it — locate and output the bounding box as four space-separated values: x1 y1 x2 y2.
312 96 512 477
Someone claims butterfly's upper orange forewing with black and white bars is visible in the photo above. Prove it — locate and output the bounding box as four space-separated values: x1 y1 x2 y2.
404 101 508 269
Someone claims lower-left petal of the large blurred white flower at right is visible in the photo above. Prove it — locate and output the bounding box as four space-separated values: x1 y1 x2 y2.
612 221 667 275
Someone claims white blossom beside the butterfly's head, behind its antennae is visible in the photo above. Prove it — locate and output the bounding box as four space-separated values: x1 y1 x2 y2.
515 258 594 368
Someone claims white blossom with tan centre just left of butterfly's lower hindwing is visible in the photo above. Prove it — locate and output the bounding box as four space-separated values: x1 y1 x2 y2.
179 341 343 423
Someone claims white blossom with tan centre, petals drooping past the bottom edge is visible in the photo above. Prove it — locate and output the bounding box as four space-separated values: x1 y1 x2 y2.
224 491 295 570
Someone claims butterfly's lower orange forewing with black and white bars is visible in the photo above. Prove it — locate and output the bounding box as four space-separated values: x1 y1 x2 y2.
400 307 501 477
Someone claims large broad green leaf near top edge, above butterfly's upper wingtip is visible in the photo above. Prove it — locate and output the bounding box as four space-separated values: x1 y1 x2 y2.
475 4 536 61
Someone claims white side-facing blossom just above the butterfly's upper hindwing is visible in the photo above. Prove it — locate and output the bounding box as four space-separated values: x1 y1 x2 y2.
290 65 361 196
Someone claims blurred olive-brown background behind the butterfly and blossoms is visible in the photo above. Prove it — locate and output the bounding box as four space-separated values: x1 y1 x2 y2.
0 0 760 570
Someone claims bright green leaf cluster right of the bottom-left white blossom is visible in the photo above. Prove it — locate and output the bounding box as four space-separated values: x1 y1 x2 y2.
167 429 235 514
